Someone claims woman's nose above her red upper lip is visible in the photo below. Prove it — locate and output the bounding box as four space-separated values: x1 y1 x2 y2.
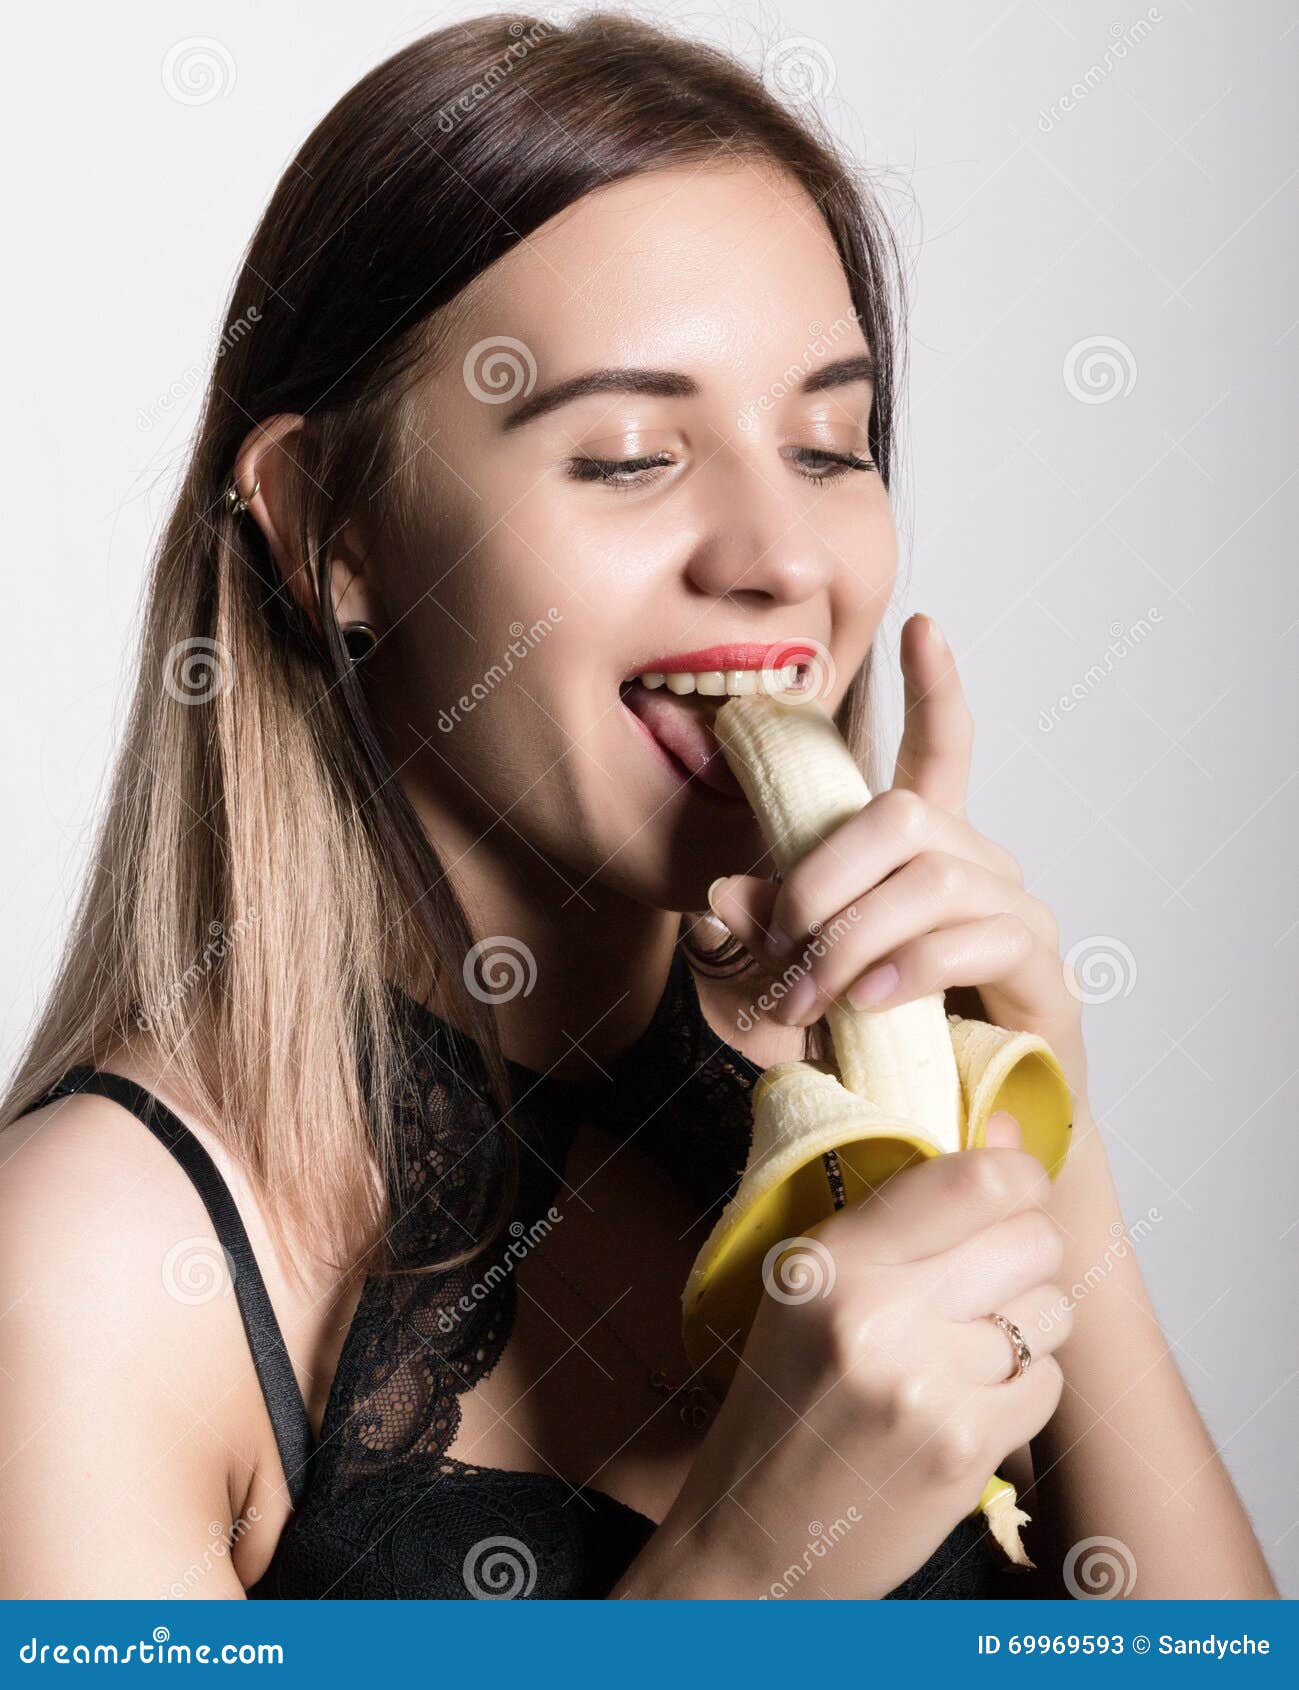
688 455 834 605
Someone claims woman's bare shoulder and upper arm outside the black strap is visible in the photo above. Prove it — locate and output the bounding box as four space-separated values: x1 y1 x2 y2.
0 1093 258 1597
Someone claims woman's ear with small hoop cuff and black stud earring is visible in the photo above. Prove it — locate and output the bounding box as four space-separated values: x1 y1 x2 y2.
235 414 378 634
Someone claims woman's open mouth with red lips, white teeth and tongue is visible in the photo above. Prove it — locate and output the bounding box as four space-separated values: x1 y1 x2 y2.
618 646 804 804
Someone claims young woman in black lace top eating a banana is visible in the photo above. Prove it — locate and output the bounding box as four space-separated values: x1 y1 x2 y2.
0 14 1274 1597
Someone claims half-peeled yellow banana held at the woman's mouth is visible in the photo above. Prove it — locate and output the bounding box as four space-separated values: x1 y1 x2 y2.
682 693 1073 1565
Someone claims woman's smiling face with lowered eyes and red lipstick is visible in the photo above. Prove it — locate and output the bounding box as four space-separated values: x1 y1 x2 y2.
361 162 895 909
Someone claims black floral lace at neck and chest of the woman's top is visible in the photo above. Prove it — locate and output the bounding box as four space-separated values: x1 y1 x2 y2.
311 950 760 1487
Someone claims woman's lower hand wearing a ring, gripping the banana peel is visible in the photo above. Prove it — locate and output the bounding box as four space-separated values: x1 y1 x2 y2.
628 1134 1069 1597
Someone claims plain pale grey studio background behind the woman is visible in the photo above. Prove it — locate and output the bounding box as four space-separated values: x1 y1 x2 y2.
0 0 1299 1595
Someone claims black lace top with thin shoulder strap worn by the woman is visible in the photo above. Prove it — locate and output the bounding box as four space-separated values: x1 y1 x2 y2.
38 950 1024 1599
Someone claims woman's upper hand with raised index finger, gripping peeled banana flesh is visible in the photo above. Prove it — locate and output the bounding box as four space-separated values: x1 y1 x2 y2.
711 615 1086 1109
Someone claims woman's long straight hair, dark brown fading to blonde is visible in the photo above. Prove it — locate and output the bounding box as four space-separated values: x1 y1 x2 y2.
0 12 900 1266
